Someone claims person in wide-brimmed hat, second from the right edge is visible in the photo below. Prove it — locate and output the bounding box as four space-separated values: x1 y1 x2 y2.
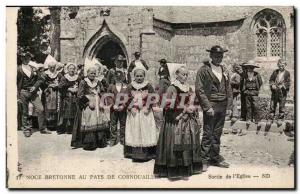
241 60 263 128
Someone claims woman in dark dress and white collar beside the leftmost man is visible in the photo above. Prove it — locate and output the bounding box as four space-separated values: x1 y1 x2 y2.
42 62 62 130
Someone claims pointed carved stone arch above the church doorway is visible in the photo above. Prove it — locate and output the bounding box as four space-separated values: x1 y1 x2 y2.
83 19 129 64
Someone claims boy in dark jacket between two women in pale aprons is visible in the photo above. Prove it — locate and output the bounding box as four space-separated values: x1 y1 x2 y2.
108 71 127 146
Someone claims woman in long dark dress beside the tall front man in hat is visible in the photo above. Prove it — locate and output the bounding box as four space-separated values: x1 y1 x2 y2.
154 66 202 179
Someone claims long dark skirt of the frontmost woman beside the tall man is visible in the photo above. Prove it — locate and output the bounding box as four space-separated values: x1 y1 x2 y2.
154 119 202 178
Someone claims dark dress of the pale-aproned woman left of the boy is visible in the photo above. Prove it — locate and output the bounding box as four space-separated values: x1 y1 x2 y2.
71 78 109 150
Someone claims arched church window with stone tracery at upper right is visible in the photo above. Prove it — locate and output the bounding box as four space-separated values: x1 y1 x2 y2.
253 9 285 61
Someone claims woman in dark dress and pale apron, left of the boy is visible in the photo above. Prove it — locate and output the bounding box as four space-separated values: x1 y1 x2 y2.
71 66 109 150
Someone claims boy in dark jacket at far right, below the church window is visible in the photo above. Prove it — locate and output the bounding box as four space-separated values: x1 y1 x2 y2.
269 59 291 119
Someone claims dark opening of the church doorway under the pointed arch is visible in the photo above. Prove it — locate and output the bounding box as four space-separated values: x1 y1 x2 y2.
96 40 127 69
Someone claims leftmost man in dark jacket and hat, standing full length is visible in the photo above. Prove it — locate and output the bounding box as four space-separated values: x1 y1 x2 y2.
17 52 50 137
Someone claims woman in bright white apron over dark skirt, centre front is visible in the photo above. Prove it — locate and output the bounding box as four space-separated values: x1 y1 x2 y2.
124 67 157 161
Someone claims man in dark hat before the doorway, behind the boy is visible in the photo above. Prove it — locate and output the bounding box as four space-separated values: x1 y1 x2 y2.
107 54 128 84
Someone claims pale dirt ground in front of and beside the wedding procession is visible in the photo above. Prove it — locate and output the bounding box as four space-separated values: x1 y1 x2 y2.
14 131 294 187
